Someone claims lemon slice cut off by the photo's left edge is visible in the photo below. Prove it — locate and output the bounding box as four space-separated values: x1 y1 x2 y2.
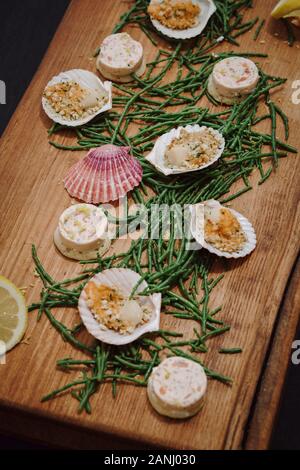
0 276 27 351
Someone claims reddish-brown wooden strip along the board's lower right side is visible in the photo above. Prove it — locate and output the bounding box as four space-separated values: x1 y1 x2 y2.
243 257 300 450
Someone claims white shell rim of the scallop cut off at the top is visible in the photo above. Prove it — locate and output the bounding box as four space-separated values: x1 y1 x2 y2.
150 0 216 39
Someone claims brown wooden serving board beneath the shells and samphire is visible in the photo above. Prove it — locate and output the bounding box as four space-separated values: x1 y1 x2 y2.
0 0 300 449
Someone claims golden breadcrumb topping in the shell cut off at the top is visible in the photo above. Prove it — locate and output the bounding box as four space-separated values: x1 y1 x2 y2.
148 0 200 29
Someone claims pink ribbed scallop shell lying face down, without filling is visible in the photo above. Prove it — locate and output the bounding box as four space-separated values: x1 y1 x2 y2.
64 144 143 204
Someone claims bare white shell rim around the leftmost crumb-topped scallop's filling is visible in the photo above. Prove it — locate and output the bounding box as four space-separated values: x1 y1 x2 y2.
42 69 112 127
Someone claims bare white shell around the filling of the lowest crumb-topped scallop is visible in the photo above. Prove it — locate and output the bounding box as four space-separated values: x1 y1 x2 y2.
78 268 161 345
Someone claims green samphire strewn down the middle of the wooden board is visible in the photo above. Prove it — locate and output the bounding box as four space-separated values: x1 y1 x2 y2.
30 0 296 413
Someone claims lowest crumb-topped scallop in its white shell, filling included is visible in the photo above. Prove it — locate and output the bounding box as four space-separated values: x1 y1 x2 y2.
78 268 161 345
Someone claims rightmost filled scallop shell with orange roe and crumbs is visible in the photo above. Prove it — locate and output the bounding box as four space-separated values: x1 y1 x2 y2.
190 199 256 258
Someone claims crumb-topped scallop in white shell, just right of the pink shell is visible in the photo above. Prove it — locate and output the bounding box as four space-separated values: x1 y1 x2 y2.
146 124 225 176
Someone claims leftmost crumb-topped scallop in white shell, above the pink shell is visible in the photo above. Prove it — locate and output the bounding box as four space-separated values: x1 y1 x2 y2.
42 69 112 127
